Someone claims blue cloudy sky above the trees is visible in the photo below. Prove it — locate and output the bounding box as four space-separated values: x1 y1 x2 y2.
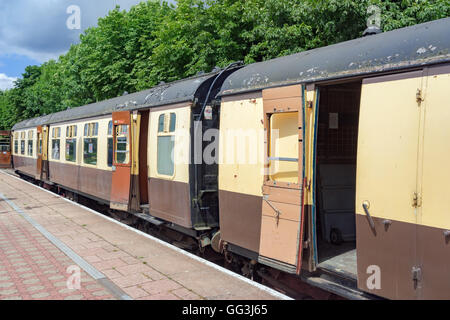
0 0 156 90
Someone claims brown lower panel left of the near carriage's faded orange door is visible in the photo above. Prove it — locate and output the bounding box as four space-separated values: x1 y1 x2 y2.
219 190 262 252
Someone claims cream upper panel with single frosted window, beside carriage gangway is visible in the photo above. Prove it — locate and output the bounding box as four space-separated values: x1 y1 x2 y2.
147 106 191 183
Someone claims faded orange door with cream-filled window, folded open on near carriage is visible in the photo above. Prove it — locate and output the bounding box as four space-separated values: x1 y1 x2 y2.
260 85 303 272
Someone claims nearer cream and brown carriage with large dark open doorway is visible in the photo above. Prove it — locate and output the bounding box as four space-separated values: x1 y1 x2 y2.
219 18 450 299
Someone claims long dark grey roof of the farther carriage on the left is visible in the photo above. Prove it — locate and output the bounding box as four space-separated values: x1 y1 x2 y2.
12 72 218 130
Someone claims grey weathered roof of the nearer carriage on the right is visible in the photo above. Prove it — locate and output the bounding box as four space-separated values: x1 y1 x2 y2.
219 18 450 96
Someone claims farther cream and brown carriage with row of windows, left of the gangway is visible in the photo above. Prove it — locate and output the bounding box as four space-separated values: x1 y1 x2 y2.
13 64 236 241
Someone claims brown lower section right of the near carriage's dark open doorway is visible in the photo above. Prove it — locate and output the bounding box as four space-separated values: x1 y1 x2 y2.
356 214 450 299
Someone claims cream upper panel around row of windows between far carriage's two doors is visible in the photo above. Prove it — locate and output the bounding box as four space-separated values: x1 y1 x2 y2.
49 116 112 171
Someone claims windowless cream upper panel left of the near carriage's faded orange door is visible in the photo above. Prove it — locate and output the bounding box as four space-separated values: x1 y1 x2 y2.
219 93 265 196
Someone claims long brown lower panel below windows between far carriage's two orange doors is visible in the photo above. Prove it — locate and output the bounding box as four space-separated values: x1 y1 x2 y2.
49 161 112 201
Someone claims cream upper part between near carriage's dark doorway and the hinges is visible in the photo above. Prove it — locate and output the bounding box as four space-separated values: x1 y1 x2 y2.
355 71 422 223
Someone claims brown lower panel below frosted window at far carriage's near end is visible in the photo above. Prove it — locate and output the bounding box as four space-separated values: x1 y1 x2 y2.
148 178 192 228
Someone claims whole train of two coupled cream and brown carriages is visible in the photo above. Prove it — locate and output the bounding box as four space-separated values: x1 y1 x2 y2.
7 18 450 299
